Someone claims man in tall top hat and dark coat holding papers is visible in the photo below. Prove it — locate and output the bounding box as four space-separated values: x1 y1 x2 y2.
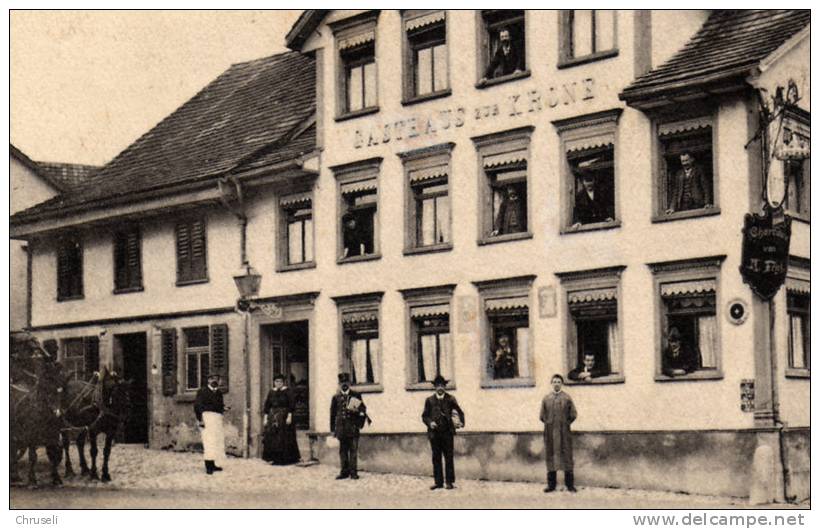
330 373 367 479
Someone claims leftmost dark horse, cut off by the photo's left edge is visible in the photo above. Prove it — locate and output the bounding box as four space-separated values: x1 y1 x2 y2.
9 335 64 487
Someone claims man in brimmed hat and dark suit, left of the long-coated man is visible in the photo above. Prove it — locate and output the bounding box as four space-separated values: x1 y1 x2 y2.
421 375 464 490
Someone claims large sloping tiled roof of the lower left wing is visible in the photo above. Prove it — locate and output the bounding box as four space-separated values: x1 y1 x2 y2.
11 48 316 224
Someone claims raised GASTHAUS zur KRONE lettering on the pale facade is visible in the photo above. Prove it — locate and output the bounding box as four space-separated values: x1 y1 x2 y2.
353 78 595 149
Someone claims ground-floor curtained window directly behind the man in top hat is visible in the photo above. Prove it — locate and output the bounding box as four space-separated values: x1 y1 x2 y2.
333 293 382 391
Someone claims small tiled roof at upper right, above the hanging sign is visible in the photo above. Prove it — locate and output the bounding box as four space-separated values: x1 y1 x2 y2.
621 9 811 102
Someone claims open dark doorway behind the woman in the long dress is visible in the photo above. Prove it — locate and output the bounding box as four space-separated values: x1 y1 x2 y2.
262 321 310 430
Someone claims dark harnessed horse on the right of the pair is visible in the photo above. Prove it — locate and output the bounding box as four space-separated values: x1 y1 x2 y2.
63 369 131 482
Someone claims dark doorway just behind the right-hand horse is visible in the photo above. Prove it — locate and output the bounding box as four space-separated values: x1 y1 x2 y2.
115 332 148 444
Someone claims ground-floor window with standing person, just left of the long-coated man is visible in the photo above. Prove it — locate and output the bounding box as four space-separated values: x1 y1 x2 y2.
474 276 535 387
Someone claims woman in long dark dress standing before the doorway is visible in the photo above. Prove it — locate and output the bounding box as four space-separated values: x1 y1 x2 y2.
262 374 301 465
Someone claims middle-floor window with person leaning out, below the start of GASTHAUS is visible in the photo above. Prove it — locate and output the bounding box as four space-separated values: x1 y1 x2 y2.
332 158 382 262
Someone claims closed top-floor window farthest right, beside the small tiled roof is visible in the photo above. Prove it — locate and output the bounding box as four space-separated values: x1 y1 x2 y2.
559 9 618 66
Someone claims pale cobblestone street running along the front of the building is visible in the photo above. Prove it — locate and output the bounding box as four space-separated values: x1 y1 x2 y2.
11 445 780 509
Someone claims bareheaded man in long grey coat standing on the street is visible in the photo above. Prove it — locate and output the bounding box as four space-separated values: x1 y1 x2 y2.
541 374 578 492
